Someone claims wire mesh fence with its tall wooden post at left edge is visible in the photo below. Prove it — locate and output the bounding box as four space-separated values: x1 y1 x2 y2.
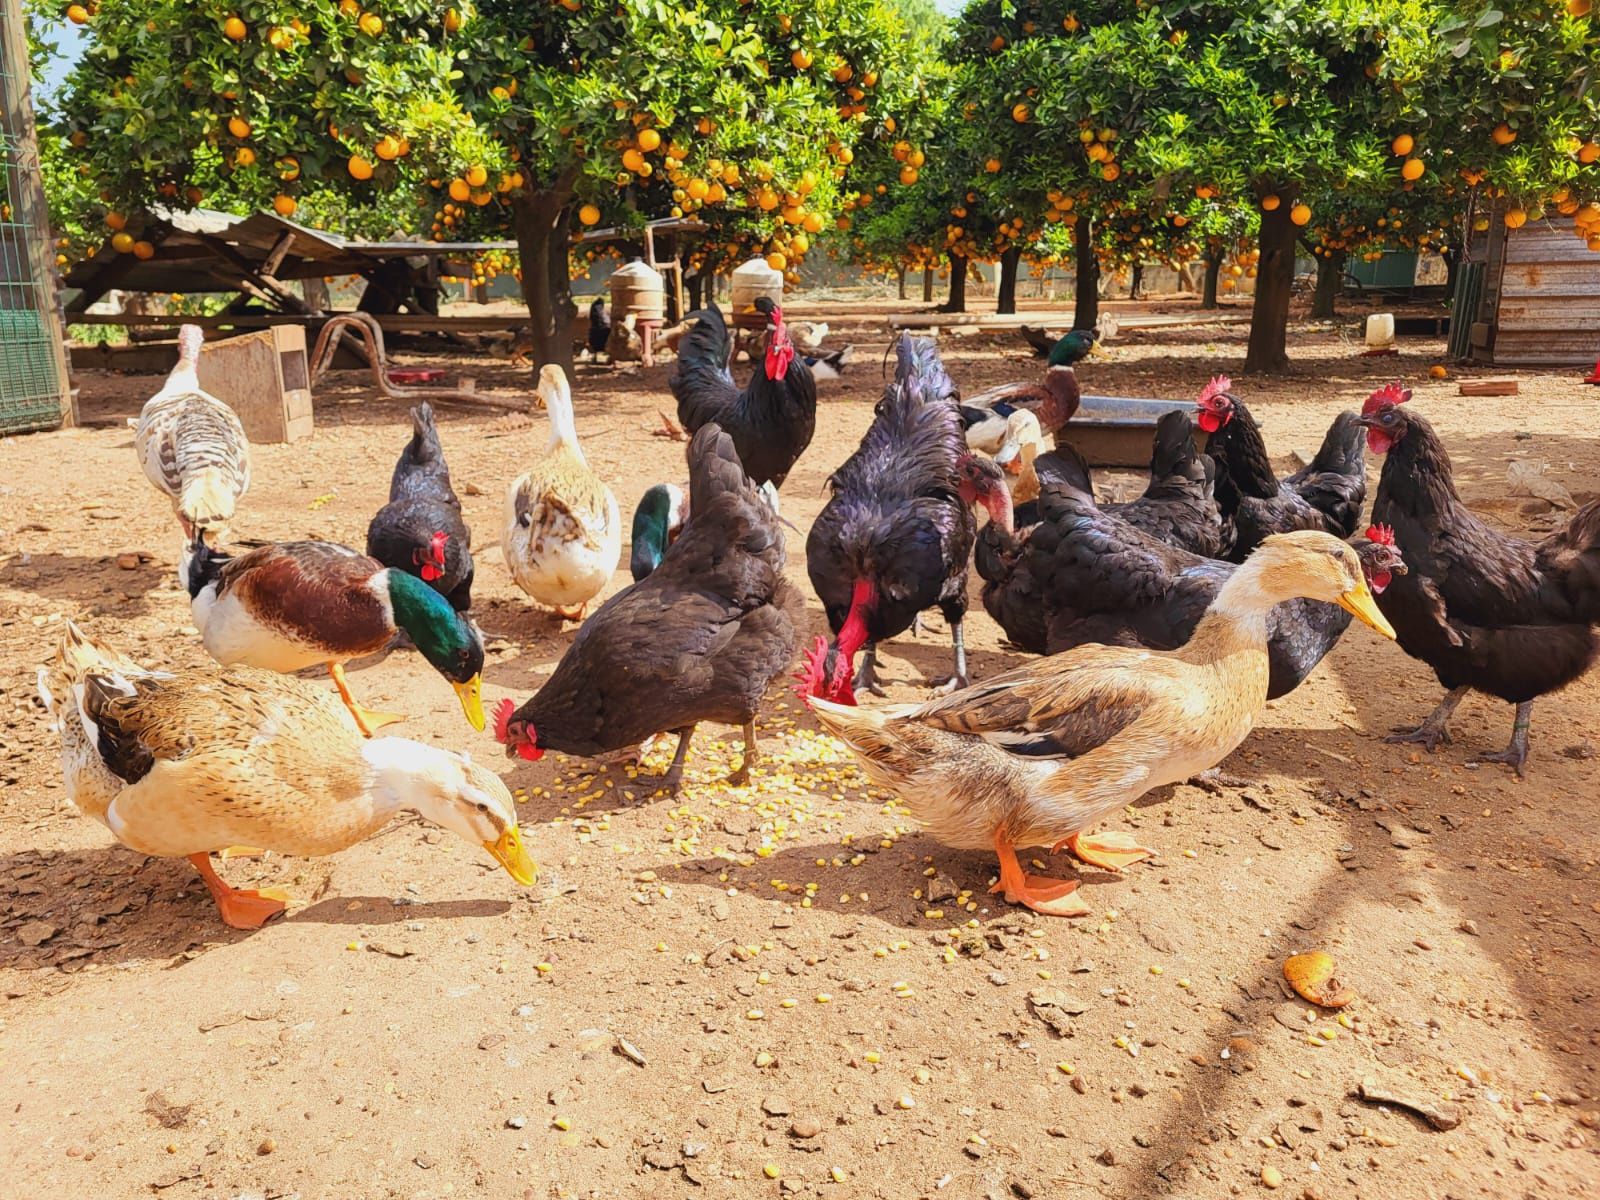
0 0 67 434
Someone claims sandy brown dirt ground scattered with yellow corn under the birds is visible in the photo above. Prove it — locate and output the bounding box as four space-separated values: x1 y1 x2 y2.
0 306 1600 1200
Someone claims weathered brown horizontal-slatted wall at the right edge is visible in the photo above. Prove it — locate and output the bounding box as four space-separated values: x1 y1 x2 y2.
1490 222 1600 366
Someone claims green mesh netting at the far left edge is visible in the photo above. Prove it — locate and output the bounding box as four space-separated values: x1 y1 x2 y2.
0 24 66 435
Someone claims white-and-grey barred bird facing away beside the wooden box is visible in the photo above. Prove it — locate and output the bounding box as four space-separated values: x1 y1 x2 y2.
128 325 250 542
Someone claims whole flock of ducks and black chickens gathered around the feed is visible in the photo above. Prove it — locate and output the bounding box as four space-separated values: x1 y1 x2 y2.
38 310 1600 928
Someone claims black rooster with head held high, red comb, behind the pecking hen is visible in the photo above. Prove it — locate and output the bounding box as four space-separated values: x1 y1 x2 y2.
669 296 816 488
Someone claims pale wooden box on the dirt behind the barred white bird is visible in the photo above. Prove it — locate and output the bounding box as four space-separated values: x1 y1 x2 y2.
198 325 312 442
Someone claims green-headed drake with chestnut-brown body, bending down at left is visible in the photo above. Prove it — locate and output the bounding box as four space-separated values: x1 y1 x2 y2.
179 539 483 736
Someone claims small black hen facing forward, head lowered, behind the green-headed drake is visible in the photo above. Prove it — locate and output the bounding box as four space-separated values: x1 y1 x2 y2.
366 400 472 613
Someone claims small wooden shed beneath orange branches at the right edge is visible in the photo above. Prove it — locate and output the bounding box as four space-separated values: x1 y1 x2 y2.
1451 214 1600 366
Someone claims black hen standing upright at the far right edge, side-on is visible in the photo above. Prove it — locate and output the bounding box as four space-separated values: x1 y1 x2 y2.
1362 384 1600 774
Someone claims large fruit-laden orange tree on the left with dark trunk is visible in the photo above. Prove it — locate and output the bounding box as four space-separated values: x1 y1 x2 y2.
56 0 909 365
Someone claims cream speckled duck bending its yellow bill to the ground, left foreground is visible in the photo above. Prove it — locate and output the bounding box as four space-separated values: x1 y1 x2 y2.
38 621 536 930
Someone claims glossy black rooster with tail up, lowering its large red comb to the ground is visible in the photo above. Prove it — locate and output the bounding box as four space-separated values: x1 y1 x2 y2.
805 334 1011 699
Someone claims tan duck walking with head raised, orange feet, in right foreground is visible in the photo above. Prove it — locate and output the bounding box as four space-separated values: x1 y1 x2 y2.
808 531 1394 917
